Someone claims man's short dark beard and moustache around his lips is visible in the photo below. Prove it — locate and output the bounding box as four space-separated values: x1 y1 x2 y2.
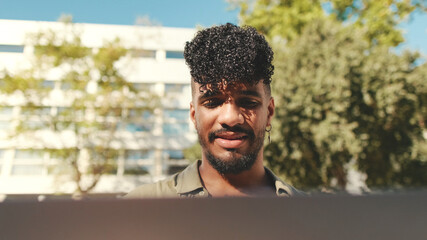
197 126 265 175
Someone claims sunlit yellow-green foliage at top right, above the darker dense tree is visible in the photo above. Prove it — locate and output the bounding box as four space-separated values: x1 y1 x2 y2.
229 0 427 46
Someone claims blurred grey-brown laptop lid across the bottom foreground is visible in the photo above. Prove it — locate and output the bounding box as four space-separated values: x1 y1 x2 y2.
0 192 427 240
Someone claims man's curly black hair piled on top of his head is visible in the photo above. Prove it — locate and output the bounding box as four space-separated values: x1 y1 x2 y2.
184 23 274 86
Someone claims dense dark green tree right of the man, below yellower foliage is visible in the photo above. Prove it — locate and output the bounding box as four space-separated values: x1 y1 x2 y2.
266 18 427 189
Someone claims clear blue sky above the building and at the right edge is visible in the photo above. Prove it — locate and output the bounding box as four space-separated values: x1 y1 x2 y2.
0 0 427 54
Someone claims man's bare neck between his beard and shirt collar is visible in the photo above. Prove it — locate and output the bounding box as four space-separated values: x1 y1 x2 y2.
199 151 275 197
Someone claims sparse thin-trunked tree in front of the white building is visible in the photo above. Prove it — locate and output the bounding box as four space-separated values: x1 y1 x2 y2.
1 18 156 194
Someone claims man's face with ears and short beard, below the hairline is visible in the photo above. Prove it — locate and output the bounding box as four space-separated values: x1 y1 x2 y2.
190 81 274 174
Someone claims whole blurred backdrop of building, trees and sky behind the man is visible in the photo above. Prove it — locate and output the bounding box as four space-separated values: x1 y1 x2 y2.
0 0 427 201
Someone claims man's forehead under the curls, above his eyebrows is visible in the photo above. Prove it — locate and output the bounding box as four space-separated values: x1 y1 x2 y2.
192 81 265 99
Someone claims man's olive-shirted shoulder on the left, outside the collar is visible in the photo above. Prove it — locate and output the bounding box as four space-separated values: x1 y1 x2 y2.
124 174 178 198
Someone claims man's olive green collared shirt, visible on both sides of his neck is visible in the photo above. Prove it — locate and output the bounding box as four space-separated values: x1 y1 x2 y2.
124 160 303 198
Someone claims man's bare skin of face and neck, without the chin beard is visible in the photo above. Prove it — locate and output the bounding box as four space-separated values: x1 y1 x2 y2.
190 81 275 197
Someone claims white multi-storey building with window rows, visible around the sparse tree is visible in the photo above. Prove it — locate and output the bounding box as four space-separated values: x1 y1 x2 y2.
0 20 197 195
